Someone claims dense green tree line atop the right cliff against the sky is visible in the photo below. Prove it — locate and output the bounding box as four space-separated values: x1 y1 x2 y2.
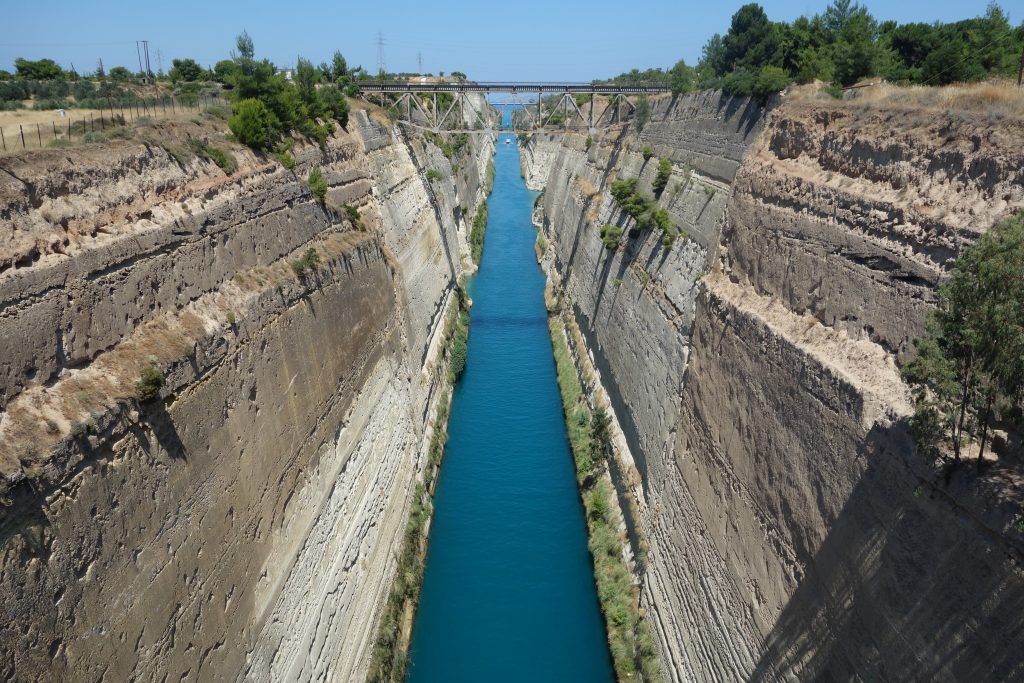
610 0 1024 99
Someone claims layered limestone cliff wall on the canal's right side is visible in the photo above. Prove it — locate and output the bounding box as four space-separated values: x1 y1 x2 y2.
523 92 1024 681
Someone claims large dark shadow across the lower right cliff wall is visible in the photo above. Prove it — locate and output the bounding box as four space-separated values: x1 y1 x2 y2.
749 426 1024 681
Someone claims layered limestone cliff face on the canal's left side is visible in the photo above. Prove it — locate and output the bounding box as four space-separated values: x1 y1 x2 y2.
0 111 493 681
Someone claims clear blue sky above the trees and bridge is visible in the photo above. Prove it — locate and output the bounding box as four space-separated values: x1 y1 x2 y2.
0 0 1007 81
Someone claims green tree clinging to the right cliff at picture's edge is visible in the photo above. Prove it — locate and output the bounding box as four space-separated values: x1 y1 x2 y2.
903 212 1024 467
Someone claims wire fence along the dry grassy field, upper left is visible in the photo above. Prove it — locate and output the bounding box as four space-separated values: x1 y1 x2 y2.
0 95 228 152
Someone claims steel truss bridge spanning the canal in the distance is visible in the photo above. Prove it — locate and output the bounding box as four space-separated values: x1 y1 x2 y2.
358 81 672 132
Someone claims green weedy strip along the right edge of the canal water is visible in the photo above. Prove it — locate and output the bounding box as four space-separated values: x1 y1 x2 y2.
548 314 662 683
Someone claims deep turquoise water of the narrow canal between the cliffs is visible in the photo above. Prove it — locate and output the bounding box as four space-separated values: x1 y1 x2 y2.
408 134 612 683
